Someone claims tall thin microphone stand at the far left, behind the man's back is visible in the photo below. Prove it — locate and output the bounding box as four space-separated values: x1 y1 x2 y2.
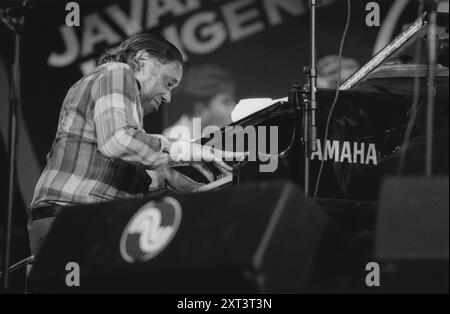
0 0 28 292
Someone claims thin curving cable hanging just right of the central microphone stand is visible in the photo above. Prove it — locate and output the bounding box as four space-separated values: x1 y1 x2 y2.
314 0 352 200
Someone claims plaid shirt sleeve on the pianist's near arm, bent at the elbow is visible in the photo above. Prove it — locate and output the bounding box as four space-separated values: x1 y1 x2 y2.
91 67 170 168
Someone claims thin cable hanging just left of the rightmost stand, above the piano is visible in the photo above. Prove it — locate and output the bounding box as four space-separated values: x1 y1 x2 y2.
397 1 425 176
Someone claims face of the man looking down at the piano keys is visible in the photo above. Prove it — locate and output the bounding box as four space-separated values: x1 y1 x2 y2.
136 57 183 115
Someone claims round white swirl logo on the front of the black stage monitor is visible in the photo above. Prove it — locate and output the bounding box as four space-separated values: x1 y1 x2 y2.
120 197 181 263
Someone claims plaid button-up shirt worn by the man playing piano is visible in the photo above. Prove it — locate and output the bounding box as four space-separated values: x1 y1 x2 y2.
31 62 170 208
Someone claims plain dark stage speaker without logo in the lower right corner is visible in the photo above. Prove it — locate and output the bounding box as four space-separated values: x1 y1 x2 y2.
376 177 449 293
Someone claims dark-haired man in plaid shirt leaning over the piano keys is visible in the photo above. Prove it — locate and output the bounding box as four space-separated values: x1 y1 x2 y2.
29 34 231 255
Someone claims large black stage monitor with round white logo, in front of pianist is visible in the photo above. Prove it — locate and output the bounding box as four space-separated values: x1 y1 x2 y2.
28 182 365 294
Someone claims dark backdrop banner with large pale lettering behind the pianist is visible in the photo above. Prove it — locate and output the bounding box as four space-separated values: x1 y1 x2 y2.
0 0 417 220
